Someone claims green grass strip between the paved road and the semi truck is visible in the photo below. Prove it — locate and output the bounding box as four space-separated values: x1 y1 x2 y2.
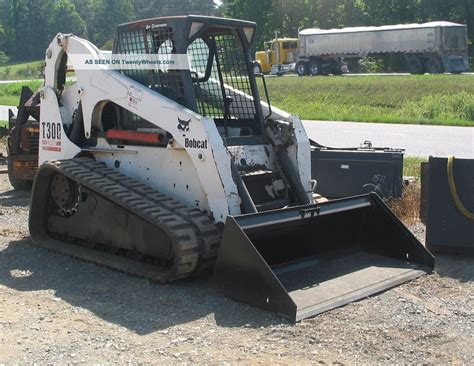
259 75 474 126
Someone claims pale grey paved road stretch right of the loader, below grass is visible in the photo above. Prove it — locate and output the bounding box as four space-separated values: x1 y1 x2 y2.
303 121 474 158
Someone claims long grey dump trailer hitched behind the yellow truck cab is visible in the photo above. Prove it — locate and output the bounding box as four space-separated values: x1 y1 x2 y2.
254 21 469 76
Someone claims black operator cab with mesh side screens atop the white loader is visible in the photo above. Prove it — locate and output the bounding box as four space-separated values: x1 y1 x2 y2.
114 15 265 145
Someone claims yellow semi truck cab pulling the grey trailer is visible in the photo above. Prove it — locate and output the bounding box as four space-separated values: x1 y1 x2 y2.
254 38 299 76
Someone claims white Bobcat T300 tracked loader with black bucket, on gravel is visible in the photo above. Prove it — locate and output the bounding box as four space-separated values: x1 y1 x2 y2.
29 16 434 320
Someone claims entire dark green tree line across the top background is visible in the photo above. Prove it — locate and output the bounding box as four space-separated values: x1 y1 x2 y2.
0 0 474 64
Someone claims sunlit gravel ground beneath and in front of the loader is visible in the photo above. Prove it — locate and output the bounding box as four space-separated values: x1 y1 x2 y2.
0 162 474 364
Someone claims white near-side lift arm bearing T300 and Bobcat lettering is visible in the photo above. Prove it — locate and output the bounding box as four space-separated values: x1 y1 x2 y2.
39 34 240 221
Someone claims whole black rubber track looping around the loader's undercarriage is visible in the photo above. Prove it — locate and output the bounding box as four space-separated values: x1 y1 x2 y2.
29 158 220 282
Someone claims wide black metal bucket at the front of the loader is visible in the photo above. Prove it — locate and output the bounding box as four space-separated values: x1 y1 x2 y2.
215 193 434 321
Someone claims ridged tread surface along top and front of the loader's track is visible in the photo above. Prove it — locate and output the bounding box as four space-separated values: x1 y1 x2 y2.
33 158 220 282
